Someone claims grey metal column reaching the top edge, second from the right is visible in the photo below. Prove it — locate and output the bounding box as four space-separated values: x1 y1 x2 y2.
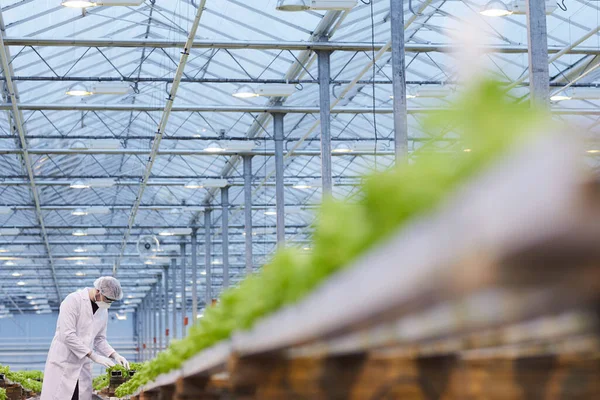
390 0 408 159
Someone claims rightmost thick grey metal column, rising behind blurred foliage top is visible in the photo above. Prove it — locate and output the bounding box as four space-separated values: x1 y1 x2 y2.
525 0 550 108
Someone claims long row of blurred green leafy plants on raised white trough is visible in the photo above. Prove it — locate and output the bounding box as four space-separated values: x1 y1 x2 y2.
116 82 545 397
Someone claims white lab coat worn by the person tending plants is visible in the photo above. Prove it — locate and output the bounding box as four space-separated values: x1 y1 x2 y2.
40 288 115 400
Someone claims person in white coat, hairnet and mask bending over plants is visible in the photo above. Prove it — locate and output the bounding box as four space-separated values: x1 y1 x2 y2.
40 276 129 400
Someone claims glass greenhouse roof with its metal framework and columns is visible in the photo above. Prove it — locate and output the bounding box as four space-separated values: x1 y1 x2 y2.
0 0 600 358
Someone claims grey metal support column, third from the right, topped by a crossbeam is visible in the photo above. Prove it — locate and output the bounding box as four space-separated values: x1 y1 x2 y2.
317 50 332 197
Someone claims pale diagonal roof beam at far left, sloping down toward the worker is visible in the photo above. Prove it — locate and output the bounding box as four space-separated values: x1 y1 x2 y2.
0 10 62 303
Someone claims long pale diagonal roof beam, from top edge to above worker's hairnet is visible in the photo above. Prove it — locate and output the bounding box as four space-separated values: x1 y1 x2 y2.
113 0 206 275
